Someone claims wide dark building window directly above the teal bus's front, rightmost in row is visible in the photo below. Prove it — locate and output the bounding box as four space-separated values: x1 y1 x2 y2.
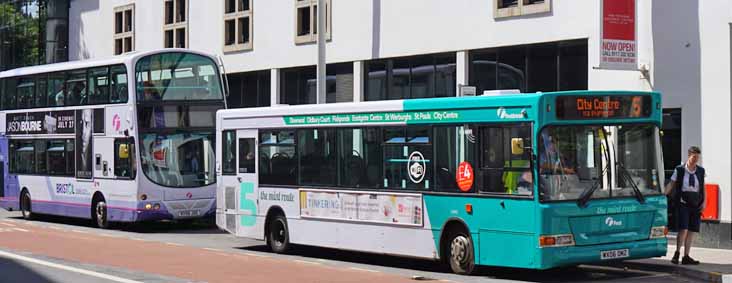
468 40 588 94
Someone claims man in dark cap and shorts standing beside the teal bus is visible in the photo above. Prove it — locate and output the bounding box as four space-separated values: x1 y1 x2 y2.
666 146 706 264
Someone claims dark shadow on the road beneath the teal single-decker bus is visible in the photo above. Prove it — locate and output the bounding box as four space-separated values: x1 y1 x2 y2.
239 245 648 282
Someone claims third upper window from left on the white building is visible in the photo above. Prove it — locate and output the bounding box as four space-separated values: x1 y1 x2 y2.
224 0 253 52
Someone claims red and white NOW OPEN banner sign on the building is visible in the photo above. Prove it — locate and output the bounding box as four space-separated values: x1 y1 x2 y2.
600 0 638 70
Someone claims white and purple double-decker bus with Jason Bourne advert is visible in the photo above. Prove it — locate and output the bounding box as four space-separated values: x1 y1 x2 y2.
0 49 225 228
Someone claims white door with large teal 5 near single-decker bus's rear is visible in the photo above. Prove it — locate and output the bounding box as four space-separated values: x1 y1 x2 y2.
225 130 264 239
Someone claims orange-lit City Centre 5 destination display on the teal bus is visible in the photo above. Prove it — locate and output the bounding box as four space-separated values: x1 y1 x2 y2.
556 95 651 120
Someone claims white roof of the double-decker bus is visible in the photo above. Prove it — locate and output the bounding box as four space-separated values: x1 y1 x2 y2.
0 48 217 79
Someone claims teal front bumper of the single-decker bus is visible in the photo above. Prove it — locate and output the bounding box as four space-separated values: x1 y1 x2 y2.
539 238 668 269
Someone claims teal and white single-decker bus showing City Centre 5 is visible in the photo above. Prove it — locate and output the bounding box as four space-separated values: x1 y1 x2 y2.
216 91 667 274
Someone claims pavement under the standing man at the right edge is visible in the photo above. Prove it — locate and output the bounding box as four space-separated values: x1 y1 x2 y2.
620 245 732 283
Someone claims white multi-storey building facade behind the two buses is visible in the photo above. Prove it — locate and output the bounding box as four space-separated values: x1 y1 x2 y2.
69 0 732 246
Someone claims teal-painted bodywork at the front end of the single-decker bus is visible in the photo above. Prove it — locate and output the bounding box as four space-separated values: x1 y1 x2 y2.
404 91 668 269
